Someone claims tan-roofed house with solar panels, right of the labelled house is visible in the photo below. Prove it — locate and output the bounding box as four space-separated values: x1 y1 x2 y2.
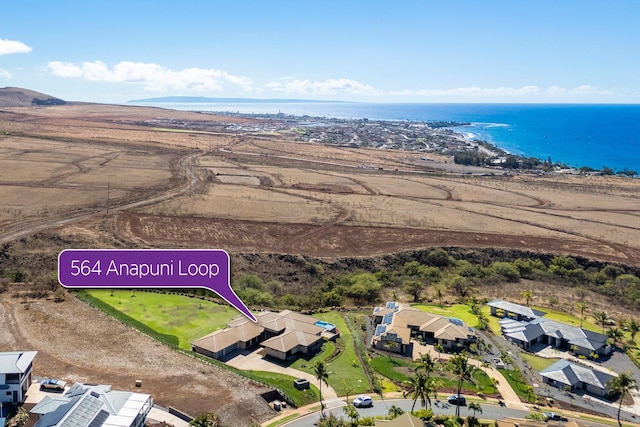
371 302 476 355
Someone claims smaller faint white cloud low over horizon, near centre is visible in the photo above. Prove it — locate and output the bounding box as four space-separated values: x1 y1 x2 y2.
265 77 384 96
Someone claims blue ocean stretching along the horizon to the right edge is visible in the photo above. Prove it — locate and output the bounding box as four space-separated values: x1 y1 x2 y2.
135 101 640 172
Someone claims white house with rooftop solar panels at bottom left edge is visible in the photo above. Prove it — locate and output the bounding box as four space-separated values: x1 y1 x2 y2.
30 383 153 427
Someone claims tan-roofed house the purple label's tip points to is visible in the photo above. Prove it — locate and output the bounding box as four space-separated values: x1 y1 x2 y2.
191 310 339 360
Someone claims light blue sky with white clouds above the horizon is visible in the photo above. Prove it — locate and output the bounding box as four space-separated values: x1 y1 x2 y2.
0 0 640 103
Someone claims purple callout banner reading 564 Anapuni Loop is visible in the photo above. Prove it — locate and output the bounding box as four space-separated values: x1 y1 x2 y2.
58 249 256 322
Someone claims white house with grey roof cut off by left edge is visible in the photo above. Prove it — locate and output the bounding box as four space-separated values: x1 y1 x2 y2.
0 351 38 405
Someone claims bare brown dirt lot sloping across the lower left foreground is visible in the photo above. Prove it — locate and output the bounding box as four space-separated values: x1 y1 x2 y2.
0 290 273 426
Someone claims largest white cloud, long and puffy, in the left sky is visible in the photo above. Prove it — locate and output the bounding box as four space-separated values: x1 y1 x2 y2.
47 61 253 92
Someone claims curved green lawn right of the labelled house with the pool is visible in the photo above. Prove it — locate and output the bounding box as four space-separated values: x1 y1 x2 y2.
291 311 370 396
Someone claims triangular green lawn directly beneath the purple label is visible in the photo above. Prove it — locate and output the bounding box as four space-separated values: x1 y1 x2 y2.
86 289 239 350
